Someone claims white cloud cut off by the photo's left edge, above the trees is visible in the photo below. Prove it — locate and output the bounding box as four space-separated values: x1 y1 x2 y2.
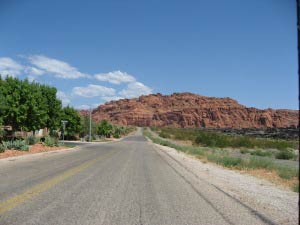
0 57 24 77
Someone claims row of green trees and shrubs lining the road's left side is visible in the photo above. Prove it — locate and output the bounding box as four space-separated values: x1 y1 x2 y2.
0 75 134 153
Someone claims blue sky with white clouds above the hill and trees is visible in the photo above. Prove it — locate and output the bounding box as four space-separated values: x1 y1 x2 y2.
0 0 298 109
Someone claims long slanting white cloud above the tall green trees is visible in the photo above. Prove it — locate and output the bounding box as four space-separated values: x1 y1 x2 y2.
28 55 90 79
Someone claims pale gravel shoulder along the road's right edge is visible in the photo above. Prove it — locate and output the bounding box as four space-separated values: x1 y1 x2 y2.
149 142 299 224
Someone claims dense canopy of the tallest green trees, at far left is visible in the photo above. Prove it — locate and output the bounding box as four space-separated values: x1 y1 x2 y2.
0 76 61 131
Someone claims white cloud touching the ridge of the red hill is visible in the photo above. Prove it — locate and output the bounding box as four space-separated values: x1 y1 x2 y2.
119 82 152 98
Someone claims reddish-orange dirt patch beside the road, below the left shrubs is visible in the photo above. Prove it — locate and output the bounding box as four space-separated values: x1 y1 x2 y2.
0 143 68 159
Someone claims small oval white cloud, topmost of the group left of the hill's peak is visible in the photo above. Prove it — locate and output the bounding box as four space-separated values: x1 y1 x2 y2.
95 70 135 84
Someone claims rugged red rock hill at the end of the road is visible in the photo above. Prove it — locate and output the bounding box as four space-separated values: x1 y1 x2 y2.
81 93 298 128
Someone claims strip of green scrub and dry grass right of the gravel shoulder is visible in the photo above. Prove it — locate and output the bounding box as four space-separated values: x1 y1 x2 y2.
144 128 299 191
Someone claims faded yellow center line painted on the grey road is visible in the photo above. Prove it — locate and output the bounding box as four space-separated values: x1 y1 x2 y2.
0 152 114 214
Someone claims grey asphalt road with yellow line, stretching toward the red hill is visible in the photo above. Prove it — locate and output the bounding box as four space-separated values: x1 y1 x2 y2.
0 130 271 225
